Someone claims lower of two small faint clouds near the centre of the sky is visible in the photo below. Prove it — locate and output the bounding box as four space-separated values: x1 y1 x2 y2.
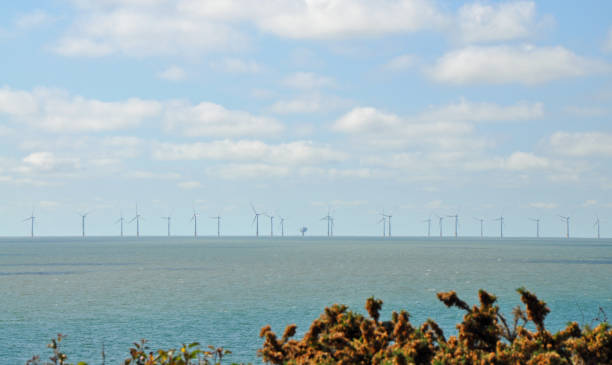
270 94 350 114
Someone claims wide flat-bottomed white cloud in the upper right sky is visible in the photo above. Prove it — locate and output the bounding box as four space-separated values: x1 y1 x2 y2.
429 45 610 85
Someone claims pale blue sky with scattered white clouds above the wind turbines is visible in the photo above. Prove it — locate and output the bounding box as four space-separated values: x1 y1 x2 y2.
0 0 612 237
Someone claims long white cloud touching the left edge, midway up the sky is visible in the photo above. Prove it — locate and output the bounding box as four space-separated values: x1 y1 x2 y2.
0 87 161 132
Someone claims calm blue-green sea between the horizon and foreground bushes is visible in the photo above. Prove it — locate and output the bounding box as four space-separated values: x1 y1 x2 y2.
0 238 612 364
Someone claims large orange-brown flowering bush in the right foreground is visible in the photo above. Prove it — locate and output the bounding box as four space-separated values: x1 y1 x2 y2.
258 288 612 365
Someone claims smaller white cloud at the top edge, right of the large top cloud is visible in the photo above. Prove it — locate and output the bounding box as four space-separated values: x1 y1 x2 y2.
457 1 536 43
